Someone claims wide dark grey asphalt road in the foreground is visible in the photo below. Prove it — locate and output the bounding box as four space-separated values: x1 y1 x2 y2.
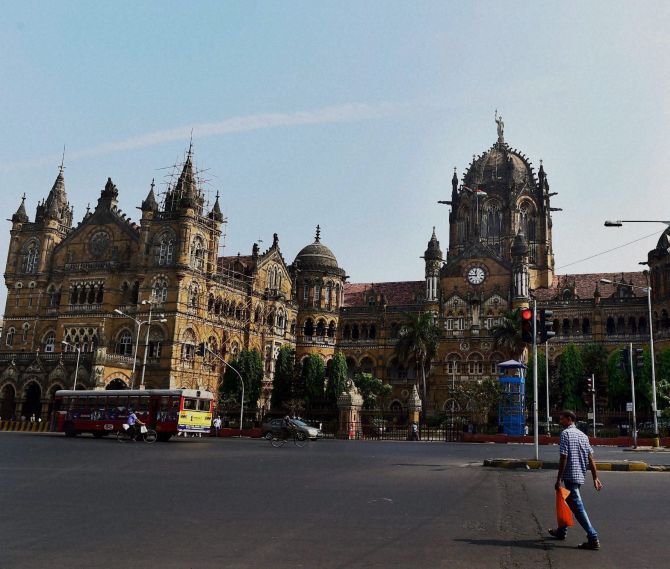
0 433 670 569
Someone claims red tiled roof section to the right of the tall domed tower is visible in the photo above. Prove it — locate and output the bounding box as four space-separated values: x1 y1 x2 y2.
533 272 647 301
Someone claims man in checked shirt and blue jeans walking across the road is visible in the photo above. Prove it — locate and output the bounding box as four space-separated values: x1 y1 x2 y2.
549 411 603 550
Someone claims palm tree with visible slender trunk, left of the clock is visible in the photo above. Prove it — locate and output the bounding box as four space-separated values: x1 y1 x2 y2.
396 312 440 409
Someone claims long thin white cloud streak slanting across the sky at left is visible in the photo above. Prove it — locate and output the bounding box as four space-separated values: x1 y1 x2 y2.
1 103 407 171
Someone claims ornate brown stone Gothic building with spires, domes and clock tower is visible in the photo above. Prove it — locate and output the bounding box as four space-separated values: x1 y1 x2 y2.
0 120 670 418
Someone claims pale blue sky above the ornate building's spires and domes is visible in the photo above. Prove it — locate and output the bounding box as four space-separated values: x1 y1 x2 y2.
0 0 670 306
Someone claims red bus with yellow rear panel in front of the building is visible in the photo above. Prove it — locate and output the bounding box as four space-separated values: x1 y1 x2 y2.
52 389 214 441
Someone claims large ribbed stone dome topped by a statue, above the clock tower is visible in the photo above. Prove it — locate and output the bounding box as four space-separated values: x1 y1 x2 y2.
463 142 535 189
